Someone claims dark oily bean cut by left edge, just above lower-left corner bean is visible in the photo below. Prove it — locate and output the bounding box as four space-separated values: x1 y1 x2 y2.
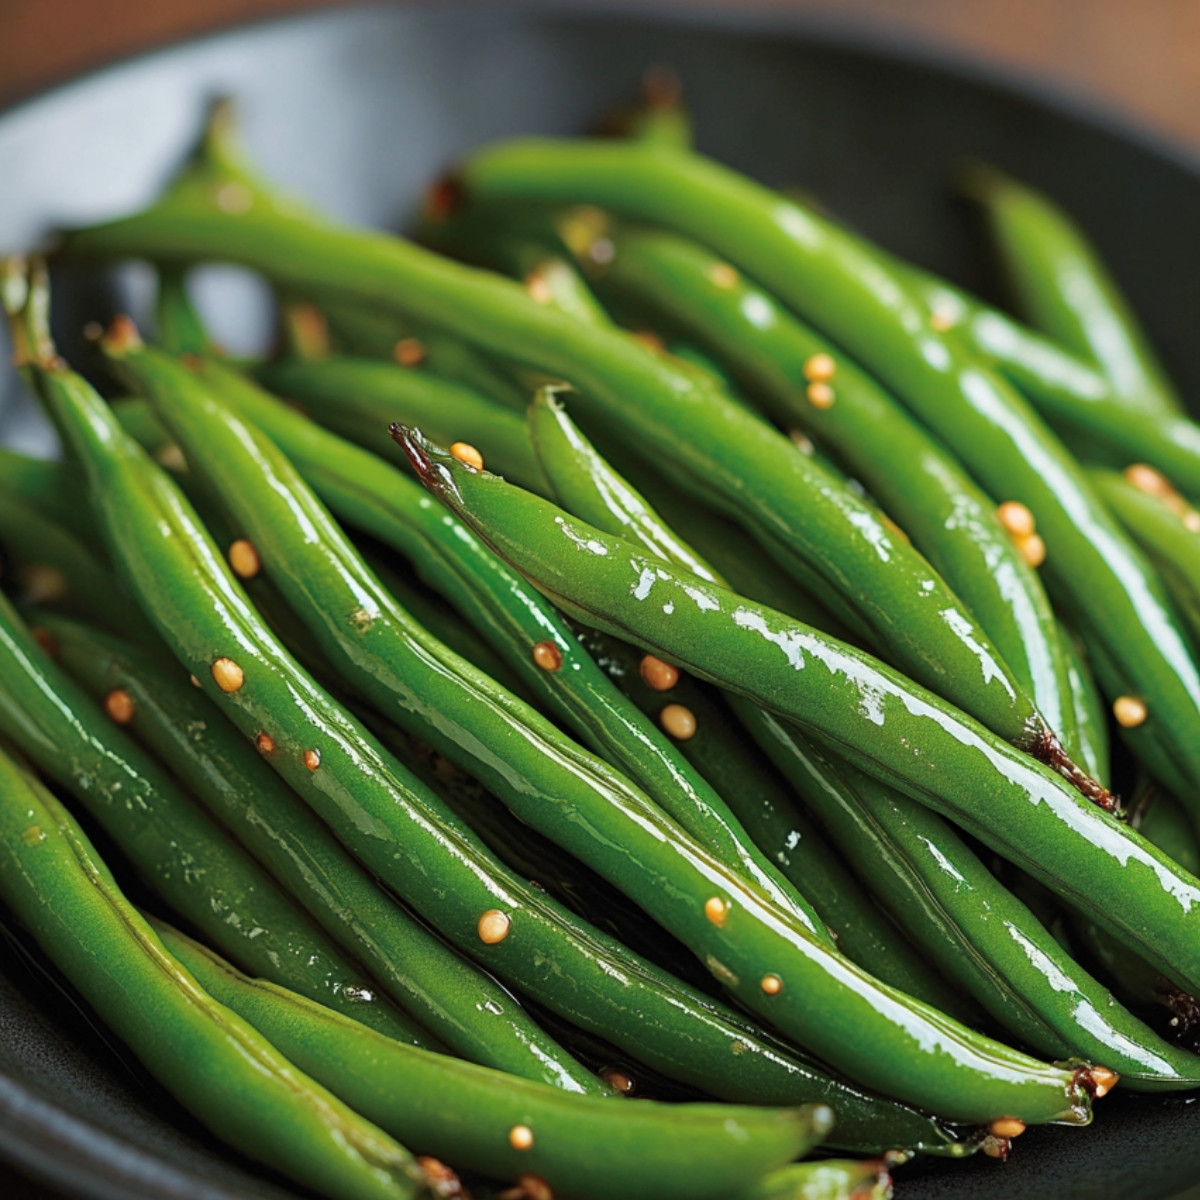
0 576 412 1038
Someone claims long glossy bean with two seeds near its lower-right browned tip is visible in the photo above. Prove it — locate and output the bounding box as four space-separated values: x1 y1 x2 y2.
117 338 1090 1122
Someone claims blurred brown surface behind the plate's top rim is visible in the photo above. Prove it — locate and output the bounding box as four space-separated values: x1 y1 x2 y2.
7 0 1200 148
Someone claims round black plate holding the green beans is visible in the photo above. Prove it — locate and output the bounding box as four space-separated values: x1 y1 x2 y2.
7 6 1200 1200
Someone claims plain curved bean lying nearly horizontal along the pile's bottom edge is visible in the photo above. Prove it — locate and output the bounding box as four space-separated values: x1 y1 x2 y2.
158 925 834 1200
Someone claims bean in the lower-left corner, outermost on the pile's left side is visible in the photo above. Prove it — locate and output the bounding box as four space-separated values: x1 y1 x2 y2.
0 754 428 1200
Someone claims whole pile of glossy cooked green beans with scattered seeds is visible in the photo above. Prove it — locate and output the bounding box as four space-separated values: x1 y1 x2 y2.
7 77 1200 1200
